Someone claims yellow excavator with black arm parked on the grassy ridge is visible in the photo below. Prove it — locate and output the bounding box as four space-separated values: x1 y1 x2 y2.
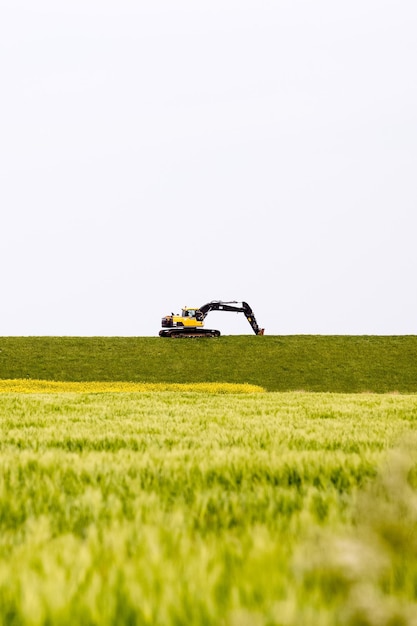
159 300 264 338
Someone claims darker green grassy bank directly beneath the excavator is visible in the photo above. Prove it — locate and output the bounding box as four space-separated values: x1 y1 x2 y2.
0 335 417 393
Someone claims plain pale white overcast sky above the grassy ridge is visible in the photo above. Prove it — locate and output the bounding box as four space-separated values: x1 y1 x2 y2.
0 0 417 336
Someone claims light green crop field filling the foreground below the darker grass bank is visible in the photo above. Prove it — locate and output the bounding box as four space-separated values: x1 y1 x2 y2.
0 386 417 626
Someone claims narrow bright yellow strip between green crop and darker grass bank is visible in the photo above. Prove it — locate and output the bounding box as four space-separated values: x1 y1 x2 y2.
0 378 265 393
